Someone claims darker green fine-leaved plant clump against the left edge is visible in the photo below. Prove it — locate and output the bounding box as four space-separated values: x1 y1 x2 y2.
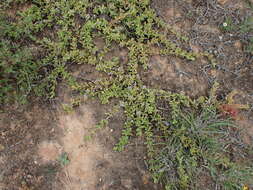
0 10 39 103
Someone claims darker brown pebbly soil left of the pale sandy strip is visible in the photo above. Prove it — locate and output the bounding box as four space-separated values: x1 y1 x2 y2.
0 104 59 190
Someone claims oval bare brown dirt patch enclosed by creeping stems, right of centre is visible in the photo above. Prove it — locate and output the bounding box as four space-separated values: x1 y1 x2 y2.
141 56 208 97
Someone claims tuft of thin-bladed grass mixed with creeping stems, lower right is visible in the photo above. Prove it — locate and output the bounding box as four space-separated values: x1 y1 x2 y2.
150 94 253 190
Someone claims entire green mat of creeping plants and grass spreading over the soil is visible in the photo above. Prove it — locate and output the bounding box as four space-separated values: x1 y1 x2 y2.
0 0 252 189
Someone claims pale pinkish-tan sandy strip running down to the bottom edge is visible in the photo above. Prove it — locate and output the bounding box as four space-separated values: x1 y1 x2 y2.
59 106 102 189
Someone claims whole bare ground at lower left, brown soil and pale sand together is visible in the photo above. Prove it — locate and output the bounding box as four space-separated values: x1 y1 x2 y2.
0 91 160 190
